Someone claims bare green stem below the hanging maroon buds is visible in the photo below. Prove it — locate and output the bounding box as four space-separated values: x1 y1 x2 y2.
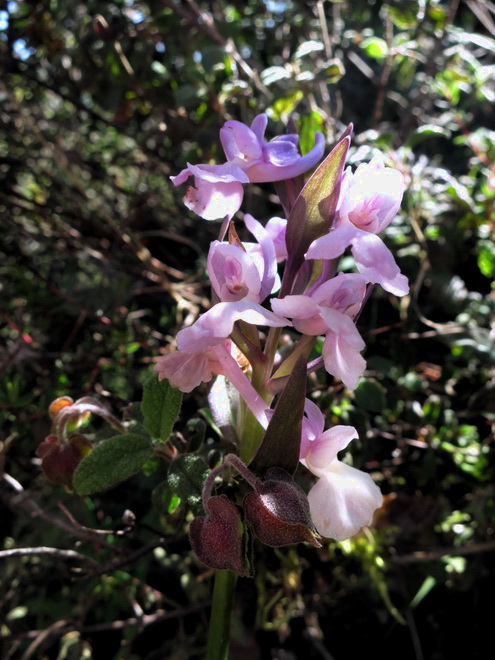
206 570 237 660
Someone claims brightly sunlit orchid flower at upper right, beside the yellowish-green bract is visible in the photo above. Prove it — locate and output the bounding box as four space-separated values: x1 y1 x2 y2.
305 156 409 296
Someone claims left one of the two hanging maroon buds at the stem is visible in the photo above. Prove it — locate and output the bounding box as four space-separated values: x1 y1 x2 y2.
189 496 253 577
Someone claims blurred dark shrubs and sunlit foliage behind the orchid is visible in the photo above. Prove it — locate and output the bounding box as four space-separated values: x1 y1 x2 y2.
0 0 495 660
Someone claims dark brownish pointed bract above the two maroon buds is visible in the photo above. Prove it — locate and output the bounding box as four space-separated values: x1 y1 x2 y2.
249 355 307 474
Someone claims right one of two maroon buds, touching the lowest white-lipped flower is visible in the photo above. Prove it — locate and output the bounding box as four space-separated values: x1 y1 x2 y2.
244 468 321 548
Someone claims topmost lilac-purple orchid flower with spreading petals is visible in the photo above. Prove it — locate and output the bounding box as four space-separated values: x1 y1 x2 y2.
170 114 325 220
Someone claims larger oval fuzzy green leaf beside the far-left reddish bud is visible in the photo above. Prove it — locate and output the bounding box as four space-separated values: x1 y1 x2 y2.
73 433 153 495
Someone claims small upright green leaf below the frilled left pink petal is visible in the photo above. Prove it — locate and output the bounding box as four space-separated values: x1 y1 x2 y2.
141 376 182 442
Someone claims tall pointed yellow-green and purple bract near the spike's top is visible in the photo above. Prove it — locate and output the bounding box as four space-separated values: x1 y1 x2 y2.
285 133 352 288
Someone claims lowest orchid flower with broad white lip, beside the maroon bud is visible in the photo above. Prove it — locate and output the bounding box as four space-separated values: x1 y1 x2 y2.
300 399 383 541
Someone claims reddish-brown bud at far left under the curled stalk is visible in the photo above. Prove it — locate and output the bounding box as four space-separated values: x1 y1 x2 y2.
36 433 93 488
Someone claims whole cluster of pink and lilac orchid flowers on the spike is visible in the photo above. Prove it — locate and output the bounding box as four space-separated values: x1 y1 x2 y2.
155 114 409 552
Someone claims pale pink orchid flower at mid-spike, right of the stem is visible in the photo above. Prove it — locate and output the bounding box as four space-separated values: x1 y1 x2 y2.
271 273 366 390
